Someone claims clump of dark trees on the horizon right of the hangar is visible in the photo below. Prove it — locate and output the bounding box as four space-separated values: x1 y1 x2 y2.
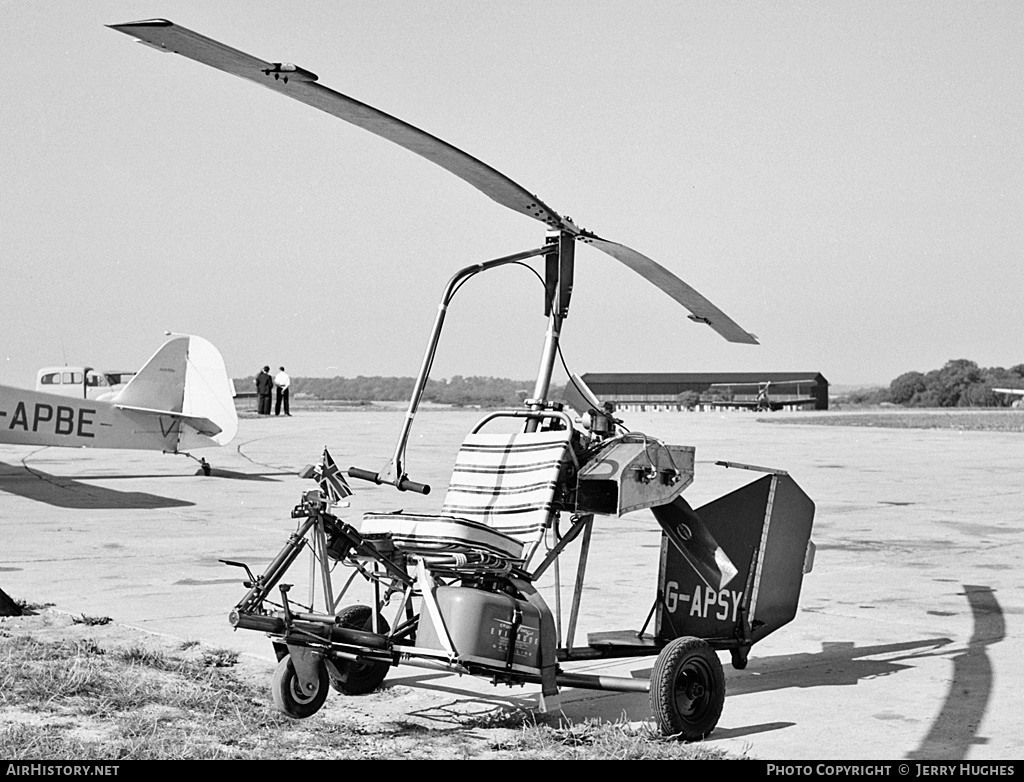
850 358 1024 407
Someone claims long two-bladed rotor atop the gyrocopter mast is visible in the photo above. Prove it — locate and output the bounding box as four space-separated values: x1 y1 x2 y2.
110 19 758 345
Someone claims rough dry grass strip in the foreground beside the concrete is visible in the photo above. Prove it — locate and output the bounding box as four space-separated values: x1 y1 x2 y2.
0 617 727 761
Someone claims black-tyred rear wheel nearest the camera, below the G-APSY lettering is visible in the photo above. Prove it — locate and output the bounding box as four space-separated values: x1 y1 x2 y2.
650 637 725 741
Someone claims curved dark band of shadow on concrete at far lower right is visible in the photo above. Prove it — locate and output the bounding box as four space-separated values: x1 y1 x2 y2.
907 584 1007 761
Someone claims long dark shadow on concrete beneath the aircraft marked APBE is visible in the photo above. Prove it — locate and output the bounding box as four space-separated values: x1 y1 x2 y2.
0 463 195 511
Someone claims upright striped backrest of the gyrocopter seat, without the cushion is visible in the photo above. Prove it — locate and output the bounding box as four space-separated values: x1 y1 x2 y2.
441 430 569 561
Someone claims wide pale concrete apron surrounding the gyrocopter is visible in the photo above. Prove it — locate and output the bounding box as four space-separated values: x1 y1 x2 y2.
0 410 1024 759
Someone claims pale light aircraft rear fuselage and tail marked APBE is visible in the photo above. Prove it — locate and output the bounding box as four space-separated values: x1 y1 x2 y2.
0 335 239 475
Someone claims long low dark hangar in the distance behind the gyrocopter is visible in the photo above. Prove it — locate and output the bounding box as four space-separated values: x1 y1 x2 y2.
583 372 828 411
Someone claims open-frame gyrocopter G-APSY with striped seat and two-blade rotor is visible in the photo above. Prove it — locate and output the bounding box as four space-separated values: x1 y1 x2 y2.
112 19 814 740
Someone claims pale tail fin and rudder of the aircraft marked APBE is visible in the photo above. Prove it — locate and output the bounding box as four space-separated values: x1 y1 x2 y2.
111 337 239 450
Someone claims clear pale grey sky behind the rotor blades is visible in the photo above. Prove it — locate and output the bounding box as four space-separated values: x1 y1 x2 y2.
0 0 1024 386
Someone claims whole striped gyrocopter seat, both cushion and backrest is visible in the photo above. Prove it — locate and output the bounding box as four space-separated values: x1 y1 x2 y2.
360 430 570 567
